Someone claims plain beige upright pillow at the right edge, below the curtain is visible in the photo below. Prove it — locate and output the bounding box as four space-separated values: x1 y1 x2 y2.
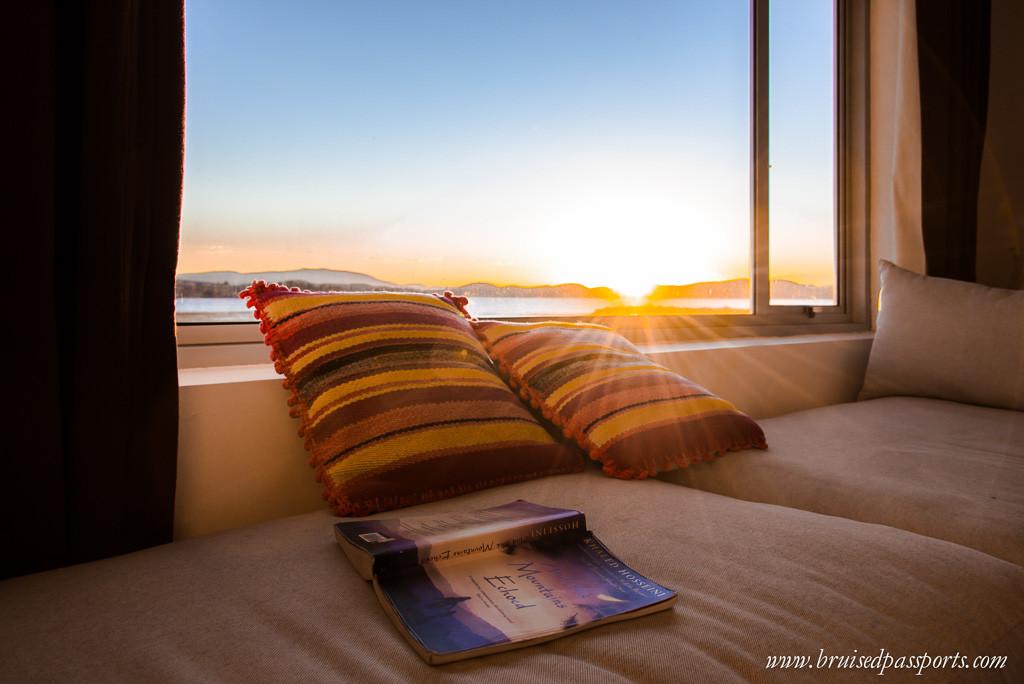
859 261 1024 411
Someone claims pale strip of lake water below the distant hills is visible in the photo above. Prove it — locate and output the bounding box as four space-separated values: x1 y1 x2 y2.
175 297 826 323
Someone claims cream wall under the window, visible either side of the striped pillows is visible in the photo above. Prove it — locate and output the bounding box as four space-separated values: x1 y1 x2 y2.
174 334 870 539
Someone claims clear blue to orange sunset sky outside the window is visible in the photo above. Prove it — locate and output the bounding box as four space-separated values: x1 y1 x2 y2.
178 0 831 294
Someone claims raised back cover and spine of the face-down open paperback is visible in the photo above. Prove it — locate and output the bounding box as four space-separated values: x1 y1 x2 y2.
334 500 587 580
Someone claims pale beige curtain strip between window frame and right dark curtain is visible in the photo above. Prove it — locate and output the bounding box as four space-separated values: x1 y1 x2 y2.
869 0 925 321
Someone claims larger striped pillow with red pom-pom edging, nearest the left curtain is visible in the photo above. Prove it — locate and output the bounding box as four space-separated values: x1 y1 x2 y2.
241 282 584 515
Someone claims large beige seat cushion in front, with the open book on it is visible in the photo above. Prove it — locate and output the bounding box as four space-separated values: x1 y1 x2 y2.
0 466 1024 684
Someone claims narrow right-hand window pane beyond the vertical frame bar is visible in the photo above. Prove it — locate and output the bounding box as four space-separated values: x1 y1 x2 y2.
768 0 836 304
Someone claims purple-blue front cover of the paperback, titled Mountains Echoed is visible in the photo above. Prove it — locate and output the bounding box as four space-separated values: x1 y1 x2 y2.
375 533 675 662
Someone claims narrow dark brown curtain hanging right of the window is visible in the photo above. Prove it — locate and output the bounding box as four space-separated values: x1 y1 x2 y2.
916 0 991 282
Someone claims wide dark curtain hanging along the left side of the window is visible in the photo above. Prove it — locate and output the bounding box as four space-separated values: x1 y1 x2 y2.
0 0 184 576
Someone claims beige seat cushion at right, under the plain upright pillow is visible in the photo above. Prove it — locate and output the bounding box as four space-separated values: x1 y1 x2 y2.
658 396 1024 566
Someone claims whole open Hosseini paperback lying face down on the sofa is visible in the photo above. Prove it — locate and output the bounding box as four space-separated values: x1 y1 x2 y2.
334 501 676 665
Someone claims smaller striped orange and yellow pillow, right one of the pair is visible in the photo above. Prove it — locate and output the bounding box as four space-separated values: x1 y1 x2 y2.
473 320 767 478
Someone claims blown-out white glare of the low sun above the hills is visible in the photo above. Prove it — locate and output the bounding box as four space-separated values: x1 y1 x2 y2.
524 164 750 305
